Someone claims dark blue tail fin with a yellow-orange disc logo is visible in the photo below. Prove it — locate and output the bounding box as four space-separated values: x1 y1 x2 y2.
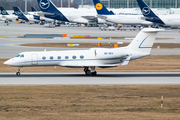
93 0 114 15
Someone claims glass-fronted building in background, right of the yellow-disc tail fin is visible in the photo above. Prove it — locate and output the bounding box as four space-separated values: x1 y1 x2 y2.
101 0 180 9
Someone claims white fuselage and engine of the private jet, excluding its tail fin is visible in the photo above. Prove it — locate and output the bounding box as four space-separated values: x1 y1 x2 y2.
4 47 149 67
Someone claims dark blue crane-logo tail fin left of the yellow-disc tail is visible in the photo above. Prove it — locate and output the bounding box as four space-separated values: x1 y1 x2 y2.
37 0 69 22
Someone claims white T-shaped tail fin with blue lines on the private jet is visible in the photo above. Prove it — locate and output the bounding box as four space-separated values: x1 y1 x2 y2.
128 28 165 53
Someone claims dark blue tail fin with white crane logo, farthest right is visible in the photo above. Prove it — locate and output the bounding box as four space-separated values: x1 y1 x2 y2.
137 0 165 25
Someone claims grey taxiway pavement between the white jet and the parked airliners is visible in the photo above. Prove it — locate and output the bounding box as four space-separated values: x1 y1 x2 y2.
0 22 180 58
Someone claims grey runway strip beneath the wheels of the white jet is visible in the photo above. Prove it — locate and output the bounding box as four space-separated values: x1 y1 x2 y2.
0 72 180 86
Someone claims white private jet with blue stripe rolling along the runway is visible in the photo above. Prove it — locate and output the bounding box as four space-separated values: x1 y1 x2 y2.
4 28 164 76
